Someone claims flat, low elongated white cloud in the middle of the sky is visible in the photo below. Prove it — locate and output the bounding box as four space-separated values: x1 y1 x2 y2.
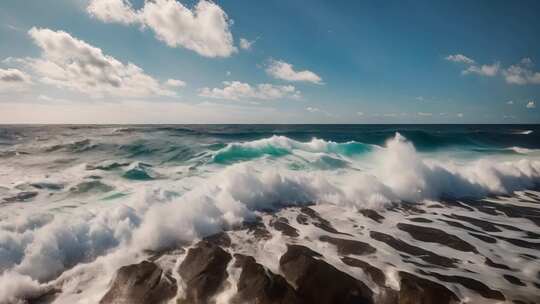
199 81 300 100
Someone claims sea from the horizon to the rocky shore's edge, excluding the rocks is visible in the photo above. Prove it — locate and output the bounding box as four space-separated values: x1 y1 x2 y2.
0 125 540 303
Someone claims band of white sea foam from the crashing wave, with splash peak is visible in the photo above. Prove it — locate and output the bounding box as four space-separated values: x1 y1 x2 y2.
0 134 540 303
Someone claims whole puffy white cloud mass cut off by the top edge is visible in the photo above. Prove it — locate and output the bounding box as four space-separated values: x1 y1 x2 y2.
87 0 237 57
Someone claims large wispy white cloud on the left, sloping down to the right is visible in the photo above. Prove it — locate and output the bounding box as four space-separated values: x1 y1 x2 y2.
22 28 174 97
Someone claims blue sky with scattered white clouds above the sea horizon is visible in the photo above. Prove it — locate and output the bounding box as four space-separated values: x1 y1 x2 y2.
0 0 540 124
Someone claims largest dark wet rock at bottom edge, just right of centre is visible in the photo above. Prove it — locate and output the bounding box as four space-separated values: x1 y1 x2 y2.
279 245 373 304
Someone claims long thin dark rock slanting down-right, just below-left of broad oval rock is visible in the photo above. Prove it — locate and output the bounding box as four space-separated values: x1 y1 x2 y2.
369 231 457 267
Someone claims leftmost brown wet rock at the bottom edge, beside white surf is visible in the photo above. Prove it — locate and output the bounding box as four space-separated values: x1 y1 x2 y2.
99 261 177 304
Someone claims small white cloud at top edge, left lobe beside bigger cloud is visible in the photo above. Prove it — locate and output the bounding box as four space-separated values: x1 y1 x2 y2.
86 0 140 24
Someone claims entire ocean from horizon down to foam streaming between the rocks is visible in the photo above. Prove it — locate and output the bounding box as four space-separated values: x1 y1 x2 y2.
0 125 540 303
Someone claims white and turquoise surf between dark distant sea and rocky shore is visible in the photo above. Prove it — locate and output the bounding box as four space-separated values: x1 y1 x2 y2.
0 125 540 303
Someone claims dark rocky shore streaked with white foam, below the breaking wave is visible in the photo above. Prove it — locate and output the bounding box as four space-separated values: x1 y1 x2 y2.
28 193 540 304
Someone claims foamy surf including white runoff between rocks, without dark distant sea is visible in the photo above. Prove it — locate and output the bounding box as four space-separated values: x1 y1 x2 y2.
0 124 540 303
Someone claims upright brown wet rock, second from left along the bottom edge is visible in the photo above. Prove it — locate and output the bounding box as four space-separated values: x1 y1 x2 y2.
178 241 231 304
